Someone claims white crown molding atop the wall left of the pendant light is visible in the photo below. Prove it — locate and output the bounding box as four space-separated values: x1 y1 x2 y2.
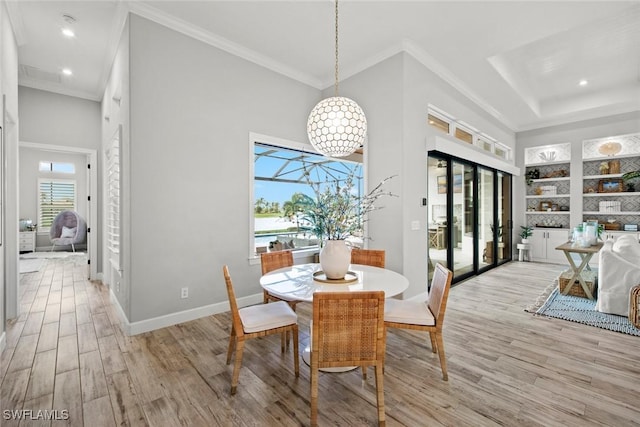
129 2 322 90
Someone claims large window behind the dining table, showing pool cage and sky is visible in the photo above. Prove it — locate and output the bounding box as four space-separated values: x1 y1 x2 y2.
251 142 364 255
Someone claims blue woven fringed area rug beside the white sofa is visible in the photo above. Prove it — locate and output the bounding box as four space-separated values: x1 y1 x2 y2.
525 282 640 336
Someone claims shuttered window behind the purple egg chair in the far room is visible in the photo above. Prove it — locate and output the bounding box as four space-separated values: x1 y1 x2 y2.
38 179 76 231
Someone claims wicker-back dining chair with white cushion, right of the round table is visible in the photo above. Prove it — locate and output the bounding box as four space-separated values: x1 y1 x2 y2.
384 264 453 381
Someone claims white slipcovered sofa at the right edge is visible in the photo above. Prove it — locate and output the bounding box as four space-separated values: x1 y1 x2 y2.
596 234 640 316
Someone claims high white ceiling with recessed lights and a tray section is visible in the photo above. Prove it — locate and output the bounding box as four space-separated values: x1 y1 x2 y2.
6 0 640 131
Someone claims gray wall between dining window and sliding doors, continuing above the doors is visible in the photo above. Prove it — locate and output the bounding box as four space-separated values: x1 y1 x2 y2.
338 53 515 298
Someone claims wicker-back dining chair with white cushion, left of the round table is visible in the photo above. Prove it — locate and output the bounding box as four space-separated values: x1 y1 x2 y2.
222 265 300 394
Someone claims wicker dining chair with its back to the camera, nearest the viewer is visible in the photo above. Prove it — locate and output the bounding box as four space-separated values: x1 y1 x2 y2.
311 291 386 426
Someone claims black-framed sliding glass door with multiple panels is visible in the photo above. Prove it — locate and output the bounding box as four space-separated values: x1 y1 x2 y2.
427 153 512 281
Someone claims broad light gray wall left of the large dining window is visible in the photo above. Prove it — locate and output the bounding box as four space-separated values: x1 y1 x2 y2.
126 15 320 322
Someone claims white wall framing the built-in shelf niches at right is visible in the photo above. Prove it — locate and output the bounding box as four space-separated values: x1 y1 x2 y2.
513 112 640 236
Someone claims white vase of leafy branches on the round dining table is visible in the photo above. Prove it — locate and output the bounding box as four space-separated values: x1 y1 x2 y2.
302 166 393 280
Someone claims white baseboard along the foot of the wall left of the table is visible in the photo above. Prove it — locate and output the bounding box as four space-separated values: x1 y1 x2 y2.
110 291 263 335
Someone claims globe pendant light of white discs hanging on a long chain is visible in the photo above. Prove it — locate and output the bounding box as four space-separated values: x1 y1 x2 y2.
307 0 367 157
